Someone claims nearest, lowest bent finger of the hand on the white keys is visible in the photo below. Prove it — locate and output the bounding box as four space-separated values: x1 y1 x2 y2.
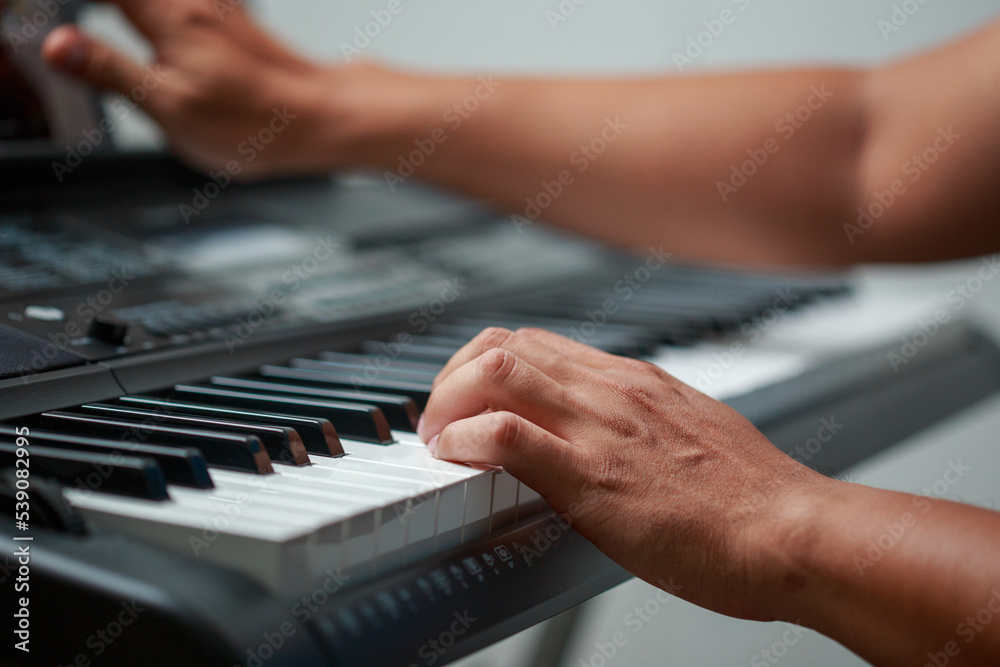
433 412 584 504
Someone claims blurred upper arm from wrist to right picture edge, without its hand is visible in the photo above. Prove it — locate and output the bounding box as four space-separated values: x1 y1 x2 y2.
331 19 1000 265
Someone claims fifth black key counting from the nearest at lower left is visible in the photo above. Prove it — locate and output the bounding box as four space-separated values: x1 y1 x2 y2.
118 396 344 457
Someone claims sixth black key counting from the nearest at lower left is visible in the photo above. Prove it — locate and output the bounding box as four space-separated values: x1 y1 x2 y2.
174 384 393 445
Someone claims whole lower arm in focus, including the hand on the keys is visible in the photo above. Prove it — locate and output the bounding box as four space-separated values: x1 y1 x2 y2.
420 329 1000 666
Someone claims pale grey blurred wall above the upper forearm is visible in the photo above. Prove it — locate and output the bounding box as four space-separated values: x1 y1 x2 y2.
256 0 1000 71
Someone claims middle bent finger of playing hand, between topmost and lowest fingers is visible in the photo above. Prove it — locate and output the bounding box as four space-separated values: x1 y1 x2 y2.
420 349 581 442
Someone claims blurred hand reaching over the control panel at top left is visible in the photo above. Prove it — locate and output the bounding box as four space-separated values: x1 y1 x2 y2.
43 0 376 178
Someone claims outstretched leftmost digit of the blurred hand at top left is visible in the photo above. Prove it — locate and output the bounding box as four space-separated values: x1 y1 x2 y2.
42 25 155 100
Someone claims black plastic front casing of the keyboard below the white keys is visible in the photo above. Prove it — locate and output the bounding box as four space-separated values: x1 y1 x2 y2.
0 514 628 667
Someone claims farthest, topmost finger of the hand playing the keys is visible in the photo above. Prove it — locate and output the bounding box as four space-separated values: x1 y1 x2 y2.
432 327 600 387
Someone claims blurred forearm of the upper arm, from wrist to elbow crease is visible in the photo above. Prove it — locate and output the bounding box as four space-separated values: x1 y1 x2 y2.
334 65 865 264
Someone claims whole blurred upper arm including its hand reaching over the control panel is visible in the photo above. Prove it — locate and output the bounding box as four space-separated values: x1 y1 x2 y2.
46 5 1000 265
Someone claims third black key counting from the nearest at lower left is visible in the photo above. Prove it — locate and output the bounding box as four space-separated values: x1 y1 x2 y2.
39 412 274 474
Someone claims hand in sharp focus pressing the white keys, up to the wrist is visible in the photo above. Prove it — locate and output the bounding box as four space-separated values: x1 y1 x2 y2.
420 329 832 620
